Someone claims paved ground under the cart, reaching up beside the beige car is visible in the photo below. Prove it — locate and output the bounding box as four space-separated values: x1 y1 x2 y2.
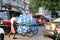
5 26 52 40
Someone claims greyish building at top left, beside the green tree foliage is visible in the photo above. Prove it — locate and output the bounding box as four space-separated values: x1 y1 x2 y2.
0 0 29 12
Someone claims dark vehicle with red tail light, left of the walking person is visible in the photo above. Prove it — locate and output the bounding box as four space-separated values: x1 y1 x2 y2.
0 10 19 33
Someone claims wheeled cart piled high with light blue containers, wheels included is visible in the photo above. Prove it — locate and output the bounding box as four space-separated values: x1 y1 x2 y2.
17 14 38 37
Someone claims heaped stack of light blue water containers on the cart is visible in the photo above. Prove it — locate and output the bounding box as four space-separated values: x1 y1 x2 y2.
16 14 36 33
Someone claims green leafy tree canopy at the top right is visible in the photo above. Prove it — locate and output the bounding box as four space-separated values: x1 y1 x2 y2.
30 0 60 12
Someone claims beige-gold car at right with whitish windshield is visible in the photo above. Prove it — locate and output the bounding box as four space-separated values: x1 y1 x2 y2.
43 18 60 37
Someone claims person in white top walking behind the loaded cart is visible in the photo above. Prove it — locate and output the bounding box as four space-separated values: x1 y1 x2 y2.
9 14 17 39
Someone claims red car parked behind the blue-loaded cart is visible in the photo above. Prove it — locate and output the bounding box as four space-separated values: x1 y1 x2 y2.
32 15 49 25
